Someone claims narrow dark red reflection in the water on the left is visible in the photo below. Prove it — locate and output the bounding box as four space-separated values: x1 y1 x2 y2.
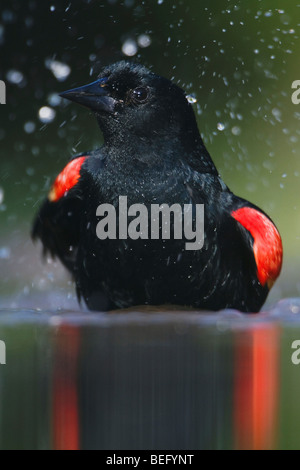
52 325 80 450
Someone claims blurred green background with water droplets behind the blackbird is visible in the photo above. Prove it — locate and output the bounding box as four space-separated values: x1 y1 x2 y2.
0 0 300 308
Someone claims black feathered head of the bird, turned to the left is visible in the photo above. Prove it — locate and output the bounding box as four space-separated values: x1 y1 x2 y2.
61 61 199 151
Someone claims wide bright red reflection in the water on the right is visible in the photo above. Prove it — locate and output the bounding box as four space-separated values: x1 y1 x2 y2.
234 325 279 450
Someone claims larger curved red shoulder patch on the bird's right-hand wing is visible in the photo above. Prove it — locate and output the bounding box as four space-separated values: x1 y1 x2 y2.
231 207 283 289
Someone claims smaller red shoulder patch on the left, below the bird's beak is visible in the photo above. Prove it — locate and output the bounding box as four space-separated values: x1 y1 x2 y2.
48 157 86 202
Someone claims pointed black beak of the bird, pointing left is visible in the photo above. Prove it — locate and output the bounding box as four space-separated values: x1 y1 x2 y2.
60 78 116 113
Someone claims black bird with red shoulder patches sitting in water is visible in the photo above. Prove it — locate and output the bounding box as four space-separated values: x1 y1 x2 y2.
32 62 282 312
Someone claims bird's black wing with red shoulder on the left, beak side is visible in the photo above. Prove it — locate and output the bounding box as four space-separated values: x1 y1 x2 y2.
31 154 89 274
